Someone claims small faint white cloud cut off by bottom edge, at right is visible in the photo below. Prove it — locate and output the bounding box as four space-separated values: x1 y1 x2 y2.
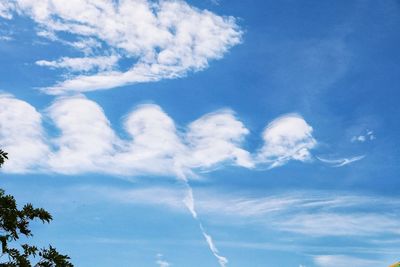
314 255 382 267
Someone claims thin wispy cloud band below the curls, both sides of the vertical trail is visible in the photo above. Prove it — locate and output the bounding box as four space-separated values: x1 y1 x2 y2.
69 184 400 241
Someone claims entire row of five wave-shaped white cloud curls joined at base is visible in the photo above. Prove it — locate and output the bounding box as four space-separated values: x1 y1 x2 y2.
0 95 316 178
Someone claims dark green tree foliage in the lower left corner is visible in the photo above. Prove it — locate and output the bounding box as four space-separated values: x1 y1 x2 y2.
0 150 73 267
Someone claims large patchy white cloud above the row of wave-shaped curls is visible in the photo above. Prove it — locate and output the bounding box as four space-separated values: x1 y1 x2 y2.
4 0 241 94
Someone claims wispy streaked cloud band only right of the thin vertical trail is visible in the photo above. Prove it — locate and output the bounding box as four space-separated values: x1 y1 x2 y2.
197 191 400 237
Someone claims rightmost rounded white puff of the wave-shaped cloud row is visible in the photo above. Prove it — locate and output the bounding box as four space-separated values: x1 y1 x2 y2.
257 114 317 168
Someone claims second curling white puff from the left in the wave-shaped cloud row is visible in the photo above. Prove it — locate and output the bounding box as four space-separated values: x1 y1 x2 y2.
47 96 118 174
